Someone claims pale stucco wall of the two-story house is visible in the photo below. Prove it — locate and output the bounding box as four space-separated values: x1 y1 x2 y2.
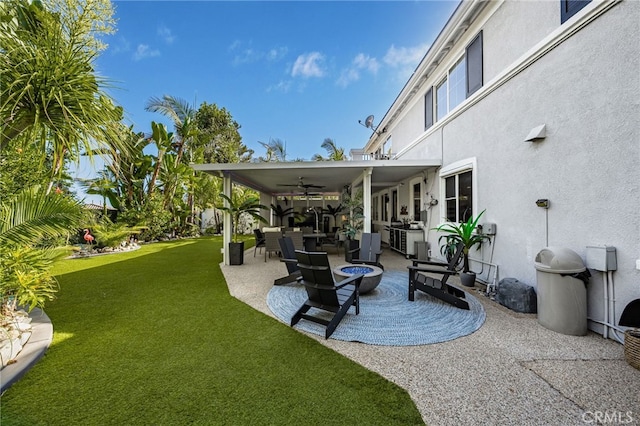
368 0 640 330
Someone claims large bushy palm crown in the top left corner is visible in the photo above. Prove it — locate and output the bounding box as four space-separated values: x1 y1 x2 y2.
0 0 128 191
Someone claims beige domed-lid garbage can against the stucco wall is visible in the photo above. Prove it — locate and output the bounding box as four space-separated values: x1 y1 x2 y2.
535 247 591 336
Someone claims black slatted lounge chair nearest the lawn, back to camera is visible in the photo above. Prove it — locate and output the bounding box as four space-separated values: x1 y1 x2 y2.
291 250 364 339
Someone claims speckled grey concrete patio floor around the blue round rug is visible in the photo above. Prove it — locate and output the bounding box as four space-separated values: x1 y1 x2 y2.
221 249 640 425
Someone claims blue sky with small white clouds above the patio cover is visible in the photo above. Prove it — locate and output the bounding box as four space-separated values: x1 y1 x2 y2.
77 0 458 203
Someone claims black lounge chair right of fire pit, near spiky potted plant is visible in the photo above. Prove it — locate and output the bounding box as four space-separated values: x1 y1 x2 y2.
407 244 469 310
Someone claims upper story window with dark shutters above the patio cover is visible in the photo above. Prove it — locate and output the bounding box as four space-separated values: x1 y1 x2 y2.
424 31 482 130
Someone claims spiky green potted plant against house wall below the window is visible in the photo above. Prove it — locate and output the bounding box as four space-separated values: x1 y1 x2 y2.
434 210 489 287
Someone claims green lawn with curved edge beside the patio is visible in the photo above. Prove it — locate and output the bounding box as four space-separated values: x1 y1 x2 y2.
0 237 422 426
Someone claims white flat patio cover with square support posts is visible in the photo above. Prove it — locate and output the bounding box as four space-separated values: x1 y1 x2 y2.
191 159 442 264
